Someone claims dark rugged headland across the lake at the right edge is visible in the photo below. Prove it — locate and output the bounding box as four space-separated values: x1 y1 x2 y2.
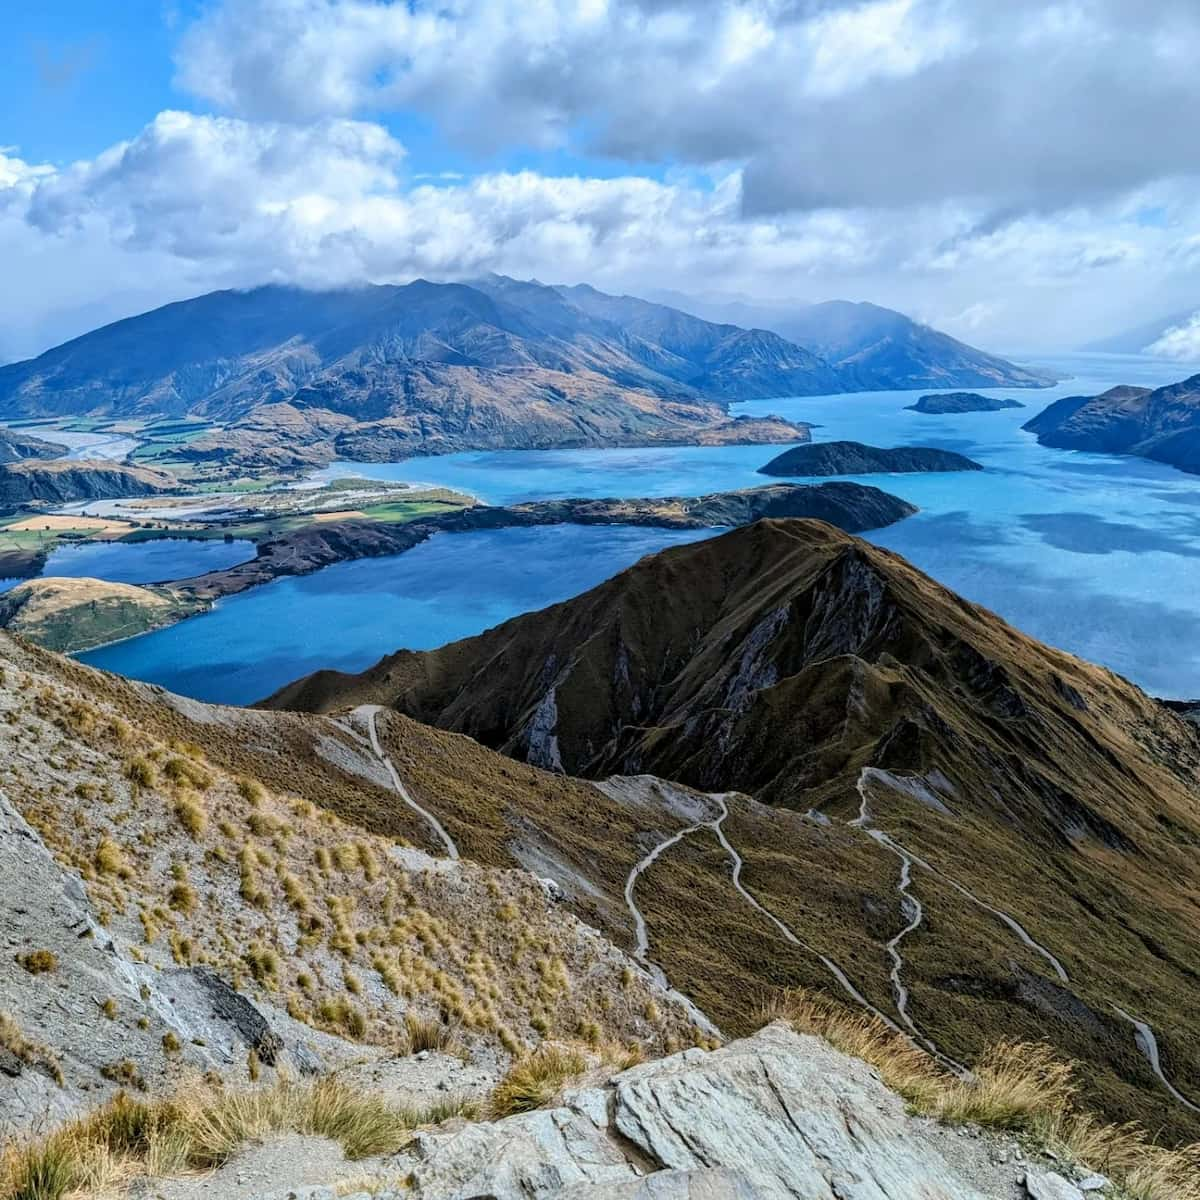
1022 376 1200 474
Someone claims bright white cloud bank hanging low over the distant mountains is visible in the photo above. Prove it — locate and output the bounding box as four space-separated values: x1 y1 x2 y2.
0 105 1200 356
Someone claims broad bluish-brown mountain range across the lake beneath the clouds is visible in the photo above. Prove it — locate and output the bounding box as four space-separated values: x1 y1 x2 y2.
0 276 1050 466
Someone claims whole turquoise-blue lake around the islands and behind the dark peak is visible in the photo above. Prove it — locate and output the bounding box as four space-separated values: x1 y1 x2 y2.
83 355 1200 702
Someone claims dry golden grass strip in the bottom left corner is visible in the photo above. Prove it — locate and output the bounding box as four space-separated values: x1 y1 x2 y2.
0 1079 474 1200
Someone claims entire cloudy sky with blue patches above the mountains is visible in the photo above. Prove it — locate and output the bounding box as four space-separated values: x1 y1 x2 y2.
7 0 1200 361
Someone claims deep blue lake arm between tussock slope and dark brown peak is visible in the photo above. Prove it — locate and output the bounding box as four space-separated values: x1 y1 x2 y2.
80 526 709 703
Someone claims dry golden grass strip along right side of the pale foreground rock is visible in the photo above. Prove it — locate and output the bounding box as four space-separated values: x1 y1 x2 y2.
763 990 1200 1200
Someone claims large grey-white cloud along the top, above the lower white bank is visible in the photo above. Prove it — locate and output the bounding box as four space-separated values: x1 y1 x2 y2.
179 0 1200 214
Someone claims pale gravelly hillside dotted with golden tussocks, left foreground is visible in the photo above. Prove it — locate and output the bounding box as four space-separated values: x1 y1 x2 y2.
0 635 703 1134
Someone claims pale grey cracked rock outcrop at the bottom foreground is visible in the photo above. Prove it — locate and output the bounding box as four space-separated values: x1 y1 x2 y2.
238 1024 1094 1200
